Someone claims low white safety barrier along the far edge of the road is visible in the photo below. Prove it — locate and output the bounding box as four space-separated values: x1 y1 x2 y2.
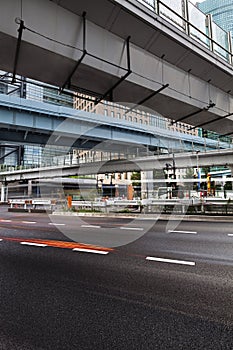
8 198 233 215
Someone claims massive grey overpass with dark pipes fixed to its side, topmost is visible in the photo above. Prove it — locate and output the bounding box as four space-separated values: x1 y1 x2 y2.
0 0 233 134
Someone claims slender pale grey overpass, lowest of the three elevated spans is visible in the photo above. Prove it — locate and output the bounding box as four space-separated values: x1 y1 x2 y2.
0 149 233 183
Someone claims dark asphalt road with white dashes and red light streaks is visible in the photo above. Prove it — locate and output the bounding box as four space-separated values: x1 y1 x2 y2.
0 208 233 350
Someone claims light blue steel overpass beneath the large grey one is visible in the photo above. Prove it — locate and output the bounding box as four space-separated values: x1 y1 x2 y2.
0 94 228 154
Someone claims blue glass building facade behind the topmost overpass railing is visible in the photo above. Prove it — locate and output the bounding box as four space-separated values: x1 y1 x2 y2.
197 0 233 36
